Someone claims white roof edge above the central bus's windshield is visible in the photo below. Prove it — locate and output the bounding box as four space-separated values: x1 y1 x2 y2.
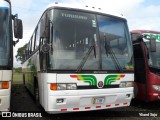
46 2 125 19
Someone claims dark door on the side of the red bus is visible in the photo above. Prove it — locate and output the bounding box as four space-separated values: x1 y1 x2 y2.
132 34 147 100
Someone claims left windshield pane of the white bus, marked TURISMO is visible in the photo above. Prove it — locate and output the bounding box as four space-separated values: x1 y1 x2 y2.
50 10 99 70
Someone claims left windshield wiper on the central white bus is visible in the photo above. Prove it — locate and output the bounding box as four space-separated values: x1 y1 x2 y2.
76 44 96 72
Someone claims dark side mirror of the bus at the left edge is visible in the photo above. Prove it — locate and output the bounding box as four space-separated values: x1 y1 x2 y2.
14 18 23 39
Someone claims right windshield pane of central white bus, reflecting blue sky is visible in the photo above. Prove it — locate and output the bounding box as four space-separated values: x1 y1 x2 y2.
98 15 133 70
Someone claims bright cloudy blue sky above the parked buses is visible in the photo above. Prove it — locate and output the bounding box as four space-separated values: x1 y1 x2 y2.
11 0 160 67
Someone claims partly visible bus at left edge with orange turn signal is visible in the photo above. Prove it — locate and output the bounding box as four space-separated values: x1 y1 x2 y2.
0 0 22 112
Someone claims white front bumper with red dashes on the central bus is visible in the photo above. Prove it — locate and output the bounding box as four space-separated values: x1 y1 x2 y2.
45 87 133 114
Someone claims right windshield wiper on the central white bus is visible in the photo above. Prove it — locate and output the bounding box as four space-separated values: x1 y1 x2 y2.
104 36 123 72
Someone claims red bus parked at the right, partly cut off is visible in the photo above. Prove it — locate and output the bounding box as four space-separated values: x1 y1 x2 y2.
131 30 160 102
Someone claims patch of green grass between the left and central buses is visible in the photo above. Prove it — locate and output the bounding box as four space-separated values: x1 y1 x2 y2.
13 72 23 84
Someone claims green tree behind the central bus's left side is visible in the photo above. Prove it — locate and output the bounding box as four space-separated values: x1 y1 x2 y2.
16 43 27 62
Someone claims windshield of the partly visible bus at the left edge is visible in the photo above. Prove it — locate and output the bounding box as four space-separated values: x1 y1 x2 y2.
0 6 10 66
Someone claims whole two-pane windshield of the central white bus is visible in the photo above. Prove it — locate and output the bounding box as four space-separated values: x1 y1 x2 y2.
49 9 133 70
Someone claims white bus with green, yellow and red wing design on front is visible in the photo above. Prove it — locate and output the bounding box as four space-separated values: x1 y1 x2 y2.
22 3 134 114
